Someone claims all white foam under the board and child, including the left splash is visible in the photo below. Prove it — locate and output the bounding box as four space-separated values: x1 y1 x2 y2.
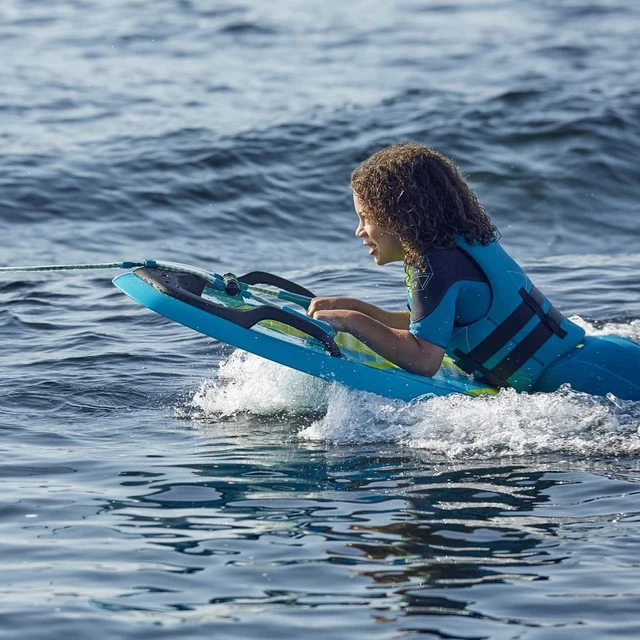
191 351 640 460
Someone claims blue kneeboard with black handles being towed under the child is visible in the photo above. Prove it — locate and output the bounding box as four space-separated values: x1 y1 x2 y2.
113 267 496 401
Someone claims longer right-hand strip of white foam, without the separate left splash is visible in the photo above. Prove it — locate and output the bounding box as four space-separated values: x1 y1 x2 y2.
299 382 640 459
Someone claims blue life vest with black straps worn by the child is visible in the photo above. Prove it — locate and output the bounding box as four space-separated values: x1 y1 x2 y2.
438 238 584 391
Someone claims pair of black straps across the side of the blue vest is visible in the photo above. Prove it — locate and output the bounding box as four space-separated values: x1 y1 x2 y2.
453 287 567 387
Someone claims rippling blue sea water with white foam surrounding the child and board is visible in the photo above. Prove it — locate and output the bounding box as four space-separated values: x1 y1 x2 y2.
0 0 640 640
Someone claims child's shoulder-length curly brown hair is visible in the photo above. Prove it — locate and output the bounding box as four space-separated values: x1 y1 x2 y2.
350 142 500 265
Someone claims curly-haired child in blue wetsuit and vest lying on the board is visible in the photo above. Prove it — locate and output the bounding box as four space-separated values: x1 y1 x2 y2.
309 143 640 400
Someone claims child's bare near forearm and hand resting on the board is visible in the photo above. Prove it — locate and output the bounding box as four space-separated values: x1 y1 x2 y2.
313 309 444 378
